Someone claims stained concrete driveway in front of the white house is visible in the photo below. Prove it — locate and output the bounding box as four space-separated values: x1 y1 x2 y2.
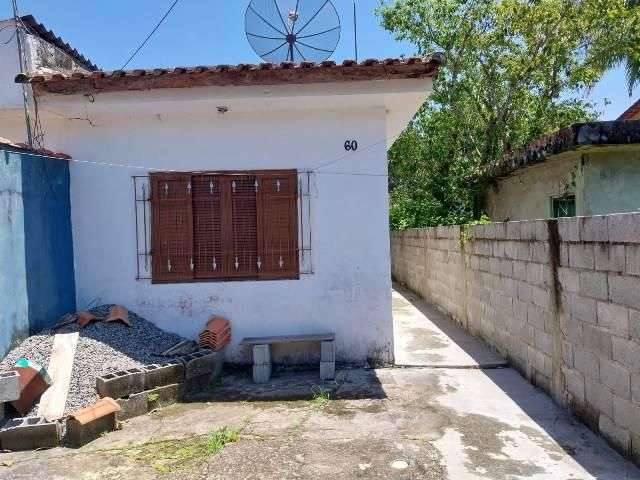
0 286 640 480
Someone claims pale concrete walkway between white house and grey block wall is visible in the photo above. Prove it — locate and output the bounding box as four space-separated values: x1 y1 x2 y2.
393 285 507 368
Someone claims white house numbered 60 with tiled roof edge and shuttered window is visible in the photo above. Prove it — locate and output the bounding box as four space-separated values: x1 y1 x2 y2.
5 26 442 361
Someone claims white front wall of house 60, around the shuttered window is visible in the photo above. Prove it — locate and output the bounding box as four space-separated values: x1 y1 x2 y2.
40 103 396 362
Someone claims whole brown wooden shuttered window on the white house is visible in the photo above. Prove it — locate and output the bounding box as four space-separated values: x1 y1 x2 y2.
149 170 299 283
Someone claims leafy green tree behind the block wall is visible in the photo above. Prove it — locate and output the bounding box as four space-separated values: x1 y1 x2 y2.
379 0 640 228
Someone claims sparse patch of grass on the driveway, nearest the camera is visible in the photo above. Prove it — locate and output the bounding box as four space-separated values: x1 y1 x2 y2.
124 427 240 473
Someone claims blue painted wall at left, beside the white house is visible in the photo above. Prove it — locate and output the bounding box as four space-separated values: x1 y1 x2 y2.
0 150 76 356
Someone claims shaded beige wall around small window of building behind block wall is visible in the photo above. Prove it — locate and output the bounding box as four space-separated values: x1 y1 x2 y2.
485 153 583 222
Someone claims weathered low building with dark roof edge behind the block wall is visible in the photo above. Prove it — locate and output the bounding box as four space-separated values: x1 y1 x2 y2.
484 121 640 221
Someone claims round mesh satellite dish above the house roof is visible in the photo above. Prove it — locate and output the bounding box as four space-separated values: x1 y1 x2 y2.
245 0 340 63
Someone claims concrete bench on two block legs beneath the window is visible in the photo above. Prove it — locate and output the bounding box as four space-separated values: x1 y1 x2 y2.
240 333 336 383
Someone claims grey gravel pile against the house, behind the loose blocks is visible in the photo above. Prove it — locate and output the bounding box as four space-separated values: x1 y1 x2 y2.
0 305 184 414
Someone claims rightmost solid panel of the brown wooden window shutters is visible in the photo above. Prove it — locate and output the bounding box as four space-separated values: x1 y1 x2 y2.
258 171 299 279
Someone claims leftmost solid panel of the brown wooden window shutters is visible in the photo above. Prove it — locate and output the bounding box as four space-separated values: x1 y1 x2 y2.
151 174 195 282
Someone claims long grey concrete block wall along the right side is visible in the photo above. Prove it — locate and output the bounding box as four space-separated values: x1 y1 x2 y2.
391 213 640 464
